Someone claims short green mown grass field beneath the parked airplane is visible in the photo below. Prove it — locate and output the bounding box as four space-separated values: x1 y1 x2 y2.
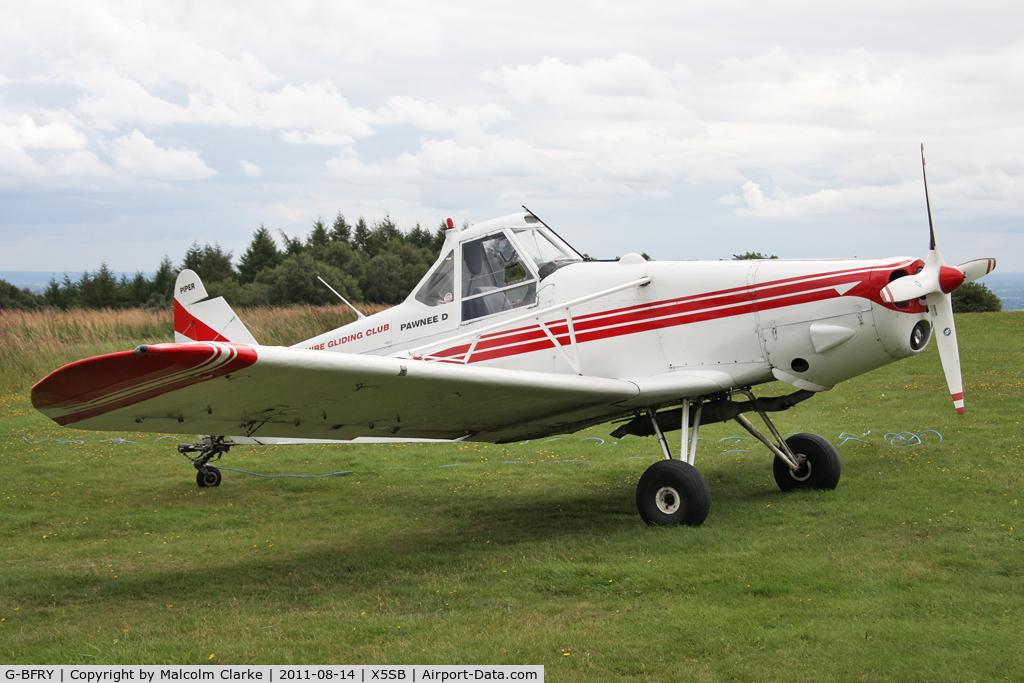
0 313 1024 683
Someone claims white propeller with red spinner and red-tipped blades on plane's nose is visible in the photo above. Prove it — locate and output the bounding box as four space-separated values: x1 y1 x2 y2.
882 144 995 415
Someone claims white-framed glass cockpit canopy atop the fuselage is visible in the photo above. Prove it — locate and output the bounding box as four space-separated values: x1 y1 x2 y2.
413 214 583 322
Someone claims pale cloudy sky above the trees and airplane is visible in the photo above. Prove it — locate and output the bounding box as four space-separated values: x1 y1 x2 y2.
0 0 1024 272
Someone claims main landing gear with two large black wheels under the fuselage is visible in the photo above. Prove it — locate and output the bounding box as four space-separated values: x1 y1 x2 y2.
611 389 842 526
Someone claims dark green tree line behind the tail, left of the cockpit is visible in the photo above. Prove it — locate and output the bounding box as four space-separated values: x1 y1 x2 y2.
0 211 445 310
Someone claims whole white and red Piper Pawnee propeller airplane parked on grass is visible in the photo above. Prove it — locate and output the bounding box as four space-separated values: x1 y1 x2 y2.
32 146 995 526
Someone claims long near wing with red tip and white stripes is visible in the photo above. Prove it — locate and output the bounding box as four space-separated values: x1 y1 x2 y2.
32 342 728 442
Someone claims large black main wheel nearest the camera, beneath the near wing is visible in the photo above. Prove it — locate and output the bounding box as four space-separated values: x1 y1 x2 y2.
637 460 711 526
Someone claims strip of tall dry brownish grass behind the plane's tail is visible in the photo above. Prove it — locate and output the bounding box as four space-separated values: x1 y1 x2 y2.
0 304 387 391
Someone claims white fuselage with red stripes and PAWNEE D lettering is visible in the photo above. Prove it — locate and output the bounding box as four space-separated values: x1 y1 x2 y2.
296 210 929 397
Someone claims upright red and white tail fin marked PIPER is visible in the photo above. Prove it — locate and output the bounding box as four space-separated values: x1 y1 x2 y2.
174 268 258 346
